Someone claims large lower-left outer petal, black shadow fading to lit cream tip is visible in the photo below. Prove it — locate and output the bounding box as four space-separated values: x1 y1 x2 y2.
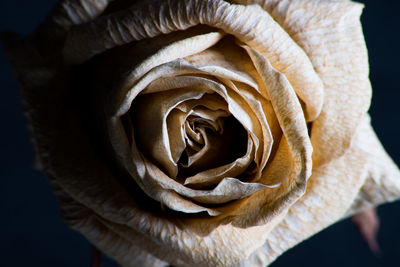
4 31 290 266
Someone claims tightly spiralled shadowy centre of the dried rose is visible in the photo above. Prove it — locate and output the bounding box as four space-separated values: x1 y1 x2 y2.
130 88 248 187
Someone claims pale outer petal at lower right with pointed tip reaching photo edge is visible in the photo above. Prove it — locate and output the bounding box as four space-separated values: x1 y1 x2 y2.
238 117 400 265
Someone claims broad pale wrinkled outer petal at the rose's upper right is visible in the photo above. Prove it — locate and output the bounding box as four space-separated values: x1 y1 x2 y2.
236 0 371 166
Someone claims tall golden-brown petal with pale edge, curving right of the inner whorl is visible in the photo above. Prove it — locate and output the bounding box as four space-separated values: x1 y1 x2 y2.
227 46 312 228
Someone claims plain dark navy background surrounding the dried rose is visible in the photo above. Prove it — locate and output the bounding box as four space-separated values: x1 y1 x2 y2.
0 0 400 267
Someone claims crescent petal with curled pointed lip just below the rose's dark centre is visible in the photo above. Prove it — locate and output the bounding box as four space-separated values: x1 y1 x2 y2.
108 101 267 210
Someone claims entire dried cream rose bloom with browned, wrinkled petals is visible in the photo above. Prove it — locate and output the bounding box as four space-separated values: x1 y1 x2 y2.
5 0 400 266
